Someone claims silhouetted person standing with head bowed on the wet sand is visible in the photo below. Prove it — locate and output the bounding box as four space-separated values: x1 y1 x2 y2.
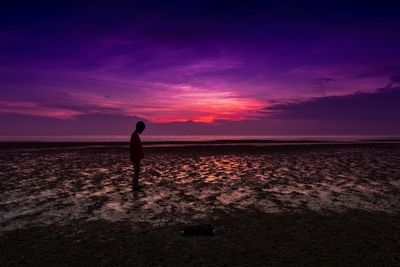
129 121 146 191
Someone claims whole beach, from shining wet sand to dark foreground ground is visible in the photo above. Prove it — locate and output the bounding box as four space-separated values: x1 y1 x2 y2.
0 142 400 266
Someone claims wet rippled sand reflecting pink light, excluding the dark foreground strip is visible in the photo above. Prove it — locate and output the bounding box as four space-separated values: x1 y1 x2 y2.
0 144 400 231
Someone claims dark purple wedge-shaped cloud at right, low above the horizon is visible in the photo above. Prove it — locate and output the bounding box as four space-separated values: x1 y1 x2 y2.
266 87 400 121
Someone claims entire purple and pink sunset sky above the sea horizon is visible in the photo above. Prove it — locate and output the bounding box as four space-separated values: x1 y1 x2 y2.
0 0 400 135
